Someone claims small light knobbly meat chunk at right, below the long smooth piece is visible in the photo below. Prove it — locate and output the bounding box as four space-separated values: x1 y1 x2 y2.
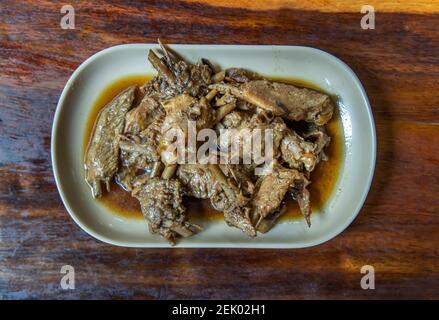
280 130 318 172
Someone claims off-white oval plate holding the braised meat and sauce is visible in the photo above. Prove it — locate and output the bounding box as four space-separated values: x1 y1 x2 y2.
51 44 376 248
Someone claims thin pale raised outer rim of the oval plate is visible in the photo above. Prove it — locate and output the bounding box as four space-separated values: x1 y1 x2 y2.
50 43 377 249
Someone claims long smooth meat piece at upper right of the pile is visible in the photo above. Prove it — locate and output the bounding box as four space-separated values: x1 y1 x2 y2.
209 80 334 125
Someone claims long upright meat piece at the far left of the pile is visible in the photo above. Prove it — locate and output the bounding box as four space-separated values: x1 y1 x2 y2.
84 86 137 198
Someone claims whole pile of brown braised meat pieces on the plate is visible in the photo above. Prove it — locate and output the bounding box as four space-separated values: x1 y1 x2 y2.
84 43 334 244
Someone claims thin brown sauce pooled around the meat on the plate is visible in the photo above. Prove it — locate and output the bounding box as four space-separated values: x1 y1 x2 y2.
83 75 344 221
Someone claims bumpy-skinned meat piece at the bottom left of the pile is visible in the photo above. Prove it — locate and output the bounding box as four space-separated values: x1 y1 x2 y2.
133 178 200 245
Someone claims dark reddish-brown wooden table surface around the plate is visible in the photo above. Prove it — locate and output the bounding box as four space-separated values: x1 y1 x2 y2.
0 0 439 299
